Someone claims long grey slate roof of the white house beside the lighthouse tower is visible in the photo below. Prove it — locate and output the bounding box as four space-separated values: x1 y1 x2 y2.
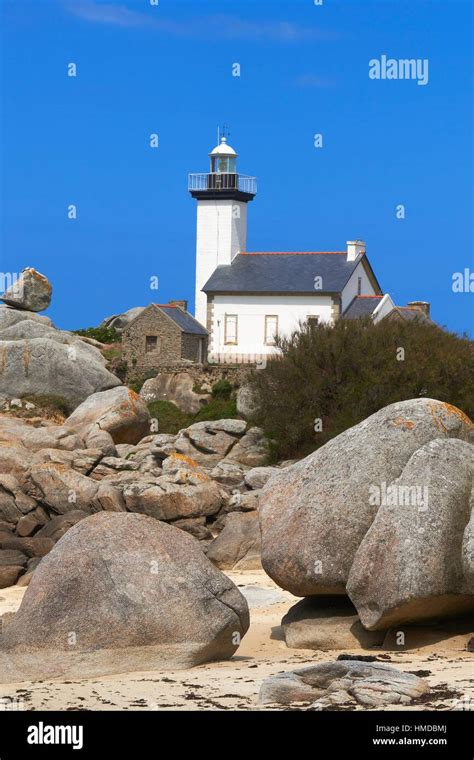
203 252 362 295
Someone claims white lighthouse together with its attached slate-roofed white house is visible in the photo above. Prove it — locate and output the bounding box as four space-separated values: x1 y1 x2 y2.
188 137 430 361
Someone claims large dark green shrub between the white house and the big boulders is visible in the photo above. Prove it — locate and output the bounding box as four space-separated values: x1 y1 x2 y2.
249 319 474 458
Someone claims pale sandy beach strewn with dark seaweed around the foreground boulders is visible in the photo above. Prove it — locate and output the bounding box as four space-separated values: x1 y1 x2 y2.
0 570 474 710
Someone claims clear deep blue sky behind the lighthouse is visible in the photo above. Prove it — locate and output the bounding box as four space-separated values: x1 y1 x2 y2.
0 0 474 332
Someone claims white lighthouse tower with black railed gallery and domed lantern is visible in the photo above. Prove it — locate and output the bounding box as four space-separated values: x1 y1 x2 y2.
188 137 257 327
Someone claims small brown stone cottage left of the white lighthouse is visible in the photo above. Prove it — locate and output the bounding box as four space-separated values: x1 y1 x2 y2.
122 301 208 371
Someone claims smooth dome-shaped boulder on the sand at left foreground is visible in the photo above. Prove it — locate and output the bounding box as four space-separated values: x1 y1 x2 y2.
0 512 249 682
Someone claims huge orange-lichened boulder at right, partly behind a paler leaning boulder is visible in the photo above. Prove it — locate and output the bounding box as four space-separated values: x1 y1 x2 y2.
259 398 472 606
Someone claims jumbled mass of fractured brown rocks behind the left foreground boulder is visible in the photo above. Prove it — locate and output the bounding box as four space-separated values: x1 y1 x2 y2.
0 412 270 585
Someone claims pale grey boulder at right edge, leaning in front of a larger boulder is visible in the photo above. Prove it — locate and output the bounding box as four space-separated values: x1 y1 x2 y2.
347 439 474 630
